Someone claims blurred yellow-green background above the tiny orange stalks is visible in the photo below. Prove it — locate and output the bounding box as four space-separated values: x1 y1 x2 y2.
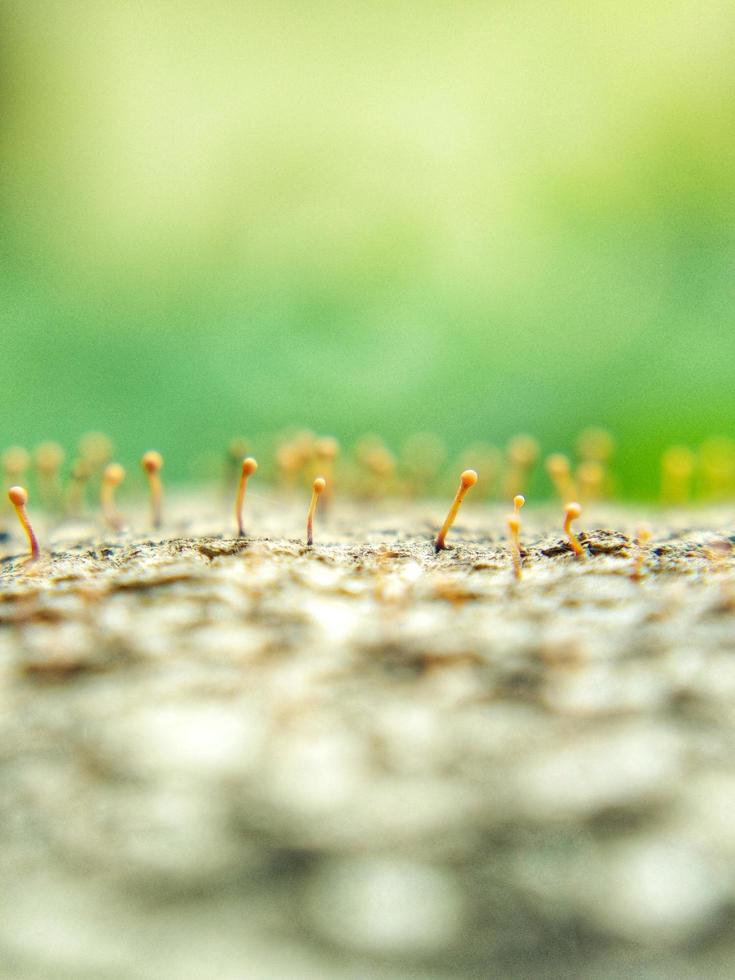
0 0 735 496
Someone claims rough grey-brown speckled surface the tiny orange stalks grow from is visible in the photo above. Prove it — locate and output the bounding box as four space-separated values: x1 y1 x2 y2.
0 500 735 980
